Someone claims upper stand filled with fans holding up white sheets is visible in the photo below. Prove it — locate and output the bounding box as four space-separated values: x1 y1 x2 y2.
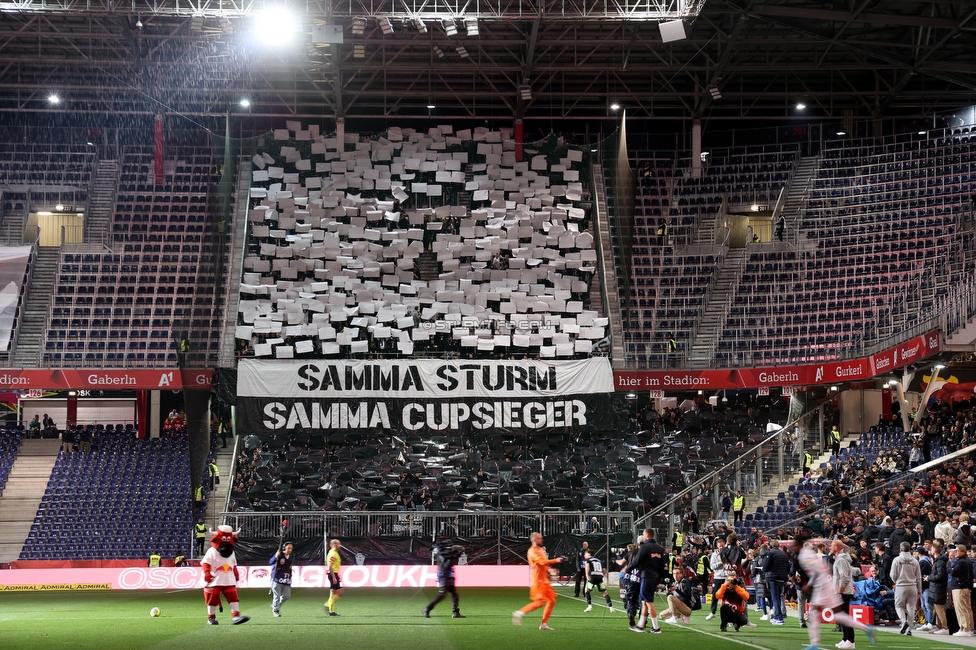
237 128 608 359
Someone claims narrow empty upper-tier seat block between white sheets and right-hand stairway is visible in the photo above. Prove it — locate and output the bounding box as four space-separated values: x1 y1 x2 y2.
618 144 799 366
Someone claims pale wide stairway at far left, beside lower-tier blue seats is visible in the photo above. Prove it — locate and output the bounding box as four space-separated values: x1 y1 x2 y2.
0 439 61 562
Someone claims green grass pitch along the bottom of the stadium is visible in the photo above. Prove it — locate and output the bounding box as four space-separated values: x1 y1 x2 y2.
0 587 959 650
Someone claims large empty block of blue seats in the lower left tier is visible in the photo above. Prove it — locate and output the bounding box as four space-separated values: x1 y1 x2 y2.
20 424 192 560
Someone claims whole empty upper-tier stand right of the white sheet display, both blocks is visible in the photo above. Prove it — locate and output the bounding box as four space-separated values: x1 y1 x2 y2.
624 131 976 366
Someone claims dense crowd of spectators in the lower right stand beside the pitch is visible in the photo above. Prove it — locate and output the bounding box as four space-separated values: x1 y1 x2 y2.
656 402 976 636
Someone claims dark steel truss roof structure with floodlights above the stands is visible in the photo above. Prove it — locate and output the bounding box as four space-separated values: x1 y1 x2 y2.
0 0 976 120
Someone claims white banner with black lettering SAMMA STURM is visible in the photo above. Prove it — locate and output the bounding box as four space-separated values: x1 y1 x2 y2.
237 357 614 399
